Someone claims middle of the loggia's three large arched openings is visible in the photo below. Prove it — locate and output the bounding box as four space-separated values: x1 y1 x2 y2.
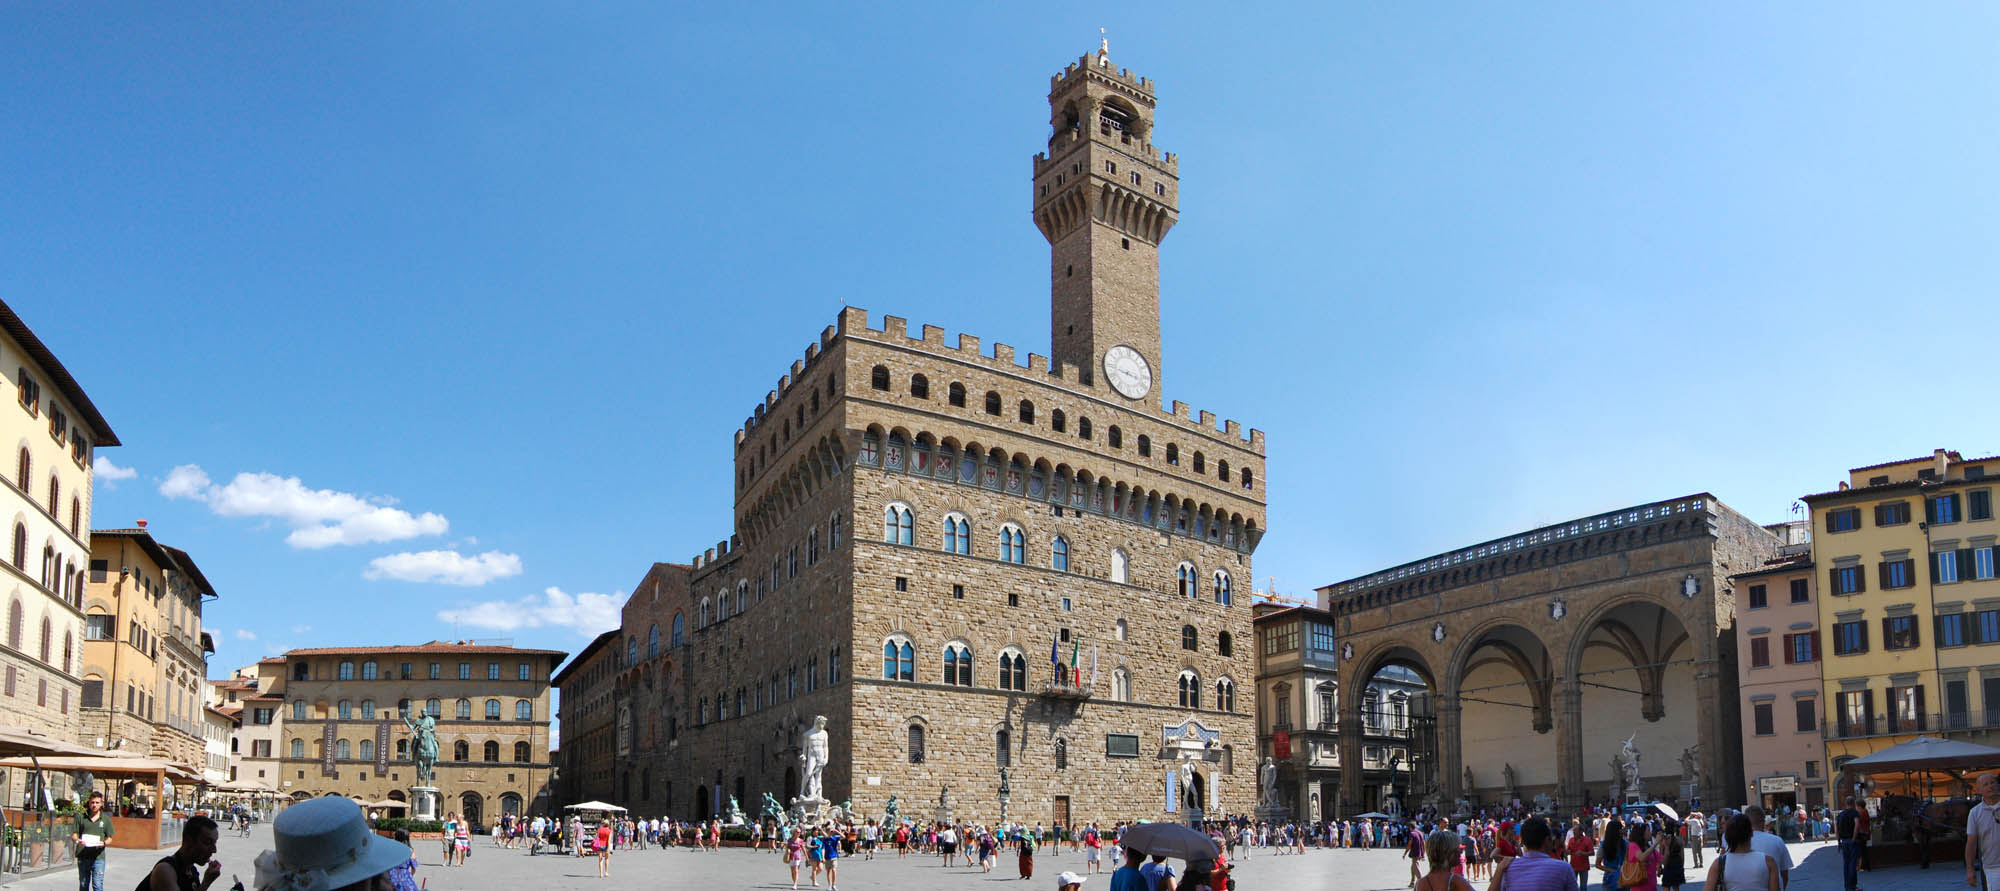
1450 623 1560 807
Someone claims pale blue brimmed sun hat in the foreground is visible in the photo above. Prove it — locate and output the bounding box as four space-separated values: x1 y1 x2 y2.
256 797 410 891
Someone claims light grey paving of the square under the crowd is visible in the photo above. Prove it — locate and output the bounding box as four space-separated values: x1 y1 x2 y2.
6 825 1904 891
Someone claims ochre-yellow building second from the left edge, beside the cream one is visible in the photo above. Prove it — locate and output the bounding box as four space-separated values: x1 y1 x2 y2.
80 527 216 771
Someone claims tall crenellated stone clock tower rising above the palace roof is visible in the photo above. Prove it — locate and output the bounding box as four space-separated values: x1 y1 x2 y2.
1034 46 1180 406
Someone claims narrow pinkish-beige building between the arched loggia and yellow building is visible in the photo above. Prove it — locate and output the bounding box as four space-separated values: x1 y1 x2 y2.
1730 523 1830 807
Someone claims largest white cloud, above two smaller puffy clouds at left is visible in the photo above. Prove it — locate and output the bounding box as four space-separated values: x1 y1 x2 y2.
160 463 450 549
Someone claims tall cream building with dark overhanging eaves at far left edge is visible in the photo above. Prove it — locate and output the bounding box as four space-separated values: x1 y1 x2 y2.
0 302 118 741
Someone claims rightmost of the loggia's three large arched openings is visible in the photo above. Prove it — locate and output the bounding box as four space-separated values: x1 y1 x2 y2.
1568 599 1696 801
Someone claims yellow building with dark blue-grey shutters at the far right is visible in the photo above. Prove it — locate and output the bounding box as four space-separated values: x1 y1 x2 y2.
1804 449 2000 787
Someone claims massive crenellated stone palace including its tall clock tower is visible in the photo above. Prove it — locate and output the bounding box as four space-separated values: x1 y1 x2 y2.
572 52 1266 825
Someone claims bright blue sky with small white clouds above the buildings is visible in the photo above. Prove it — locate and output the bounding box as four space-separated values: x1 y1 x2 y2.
0 2 2000 691
